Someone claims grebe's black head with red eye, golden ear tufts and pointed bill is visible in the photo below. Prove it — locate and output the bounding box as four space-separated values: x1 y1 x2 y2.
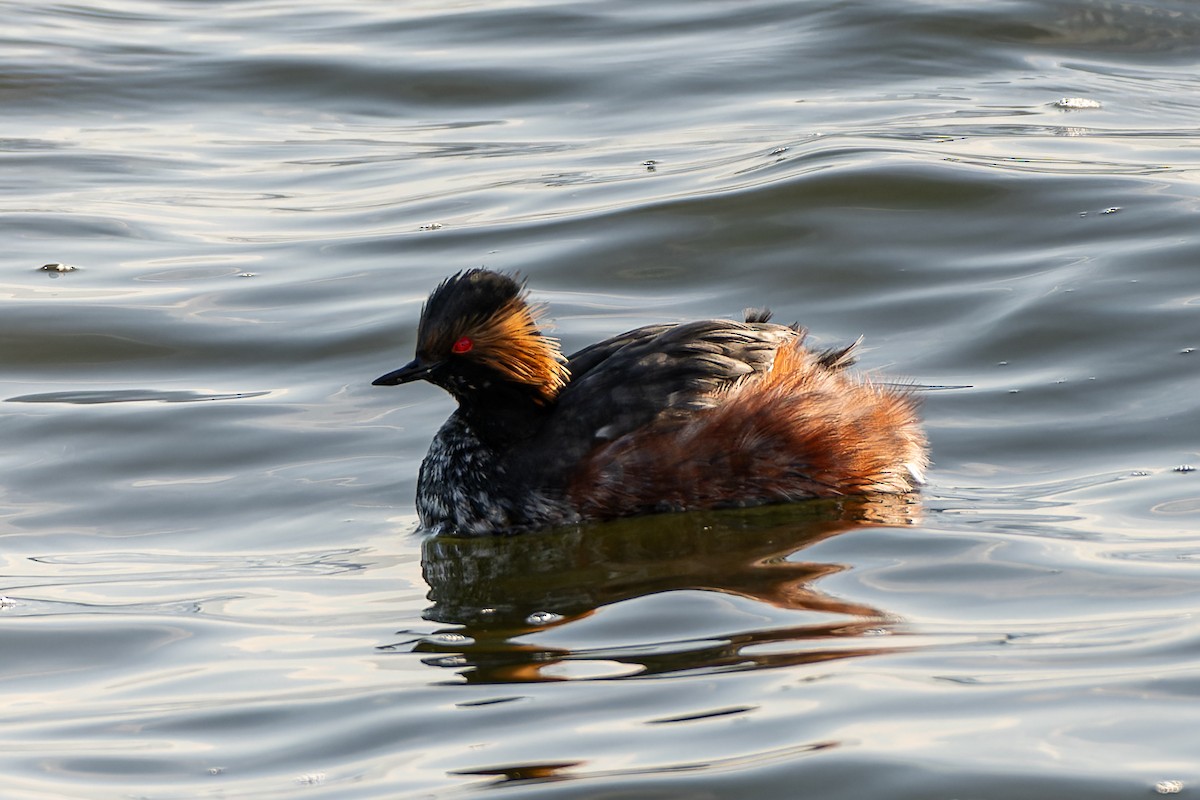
373 269 568 404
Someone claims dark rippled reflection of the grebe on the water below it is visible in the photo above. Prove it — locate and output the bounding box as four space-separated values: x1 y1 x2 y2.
403 495 919 682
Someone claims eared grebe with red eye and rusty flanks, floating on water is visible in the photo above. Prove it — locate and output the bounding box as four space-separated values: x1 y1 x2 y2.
374 269 926 535
